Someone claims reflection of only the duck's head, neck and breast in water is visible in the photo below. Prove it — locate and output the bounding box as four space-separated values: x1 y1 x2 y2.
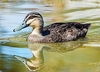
15 43 44 71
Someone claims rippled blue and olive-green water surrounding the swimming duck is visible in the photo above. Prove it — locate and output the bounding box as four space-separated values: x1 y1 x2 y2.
0 0 100 72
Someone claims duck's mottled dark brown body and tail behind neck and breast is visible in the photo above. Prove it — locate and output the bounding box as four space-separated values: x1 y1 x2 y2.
42 22 91 42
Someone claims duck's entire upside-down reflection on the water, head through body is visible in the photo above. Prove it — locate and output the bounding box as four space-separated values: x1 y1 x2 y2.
15 41 82 71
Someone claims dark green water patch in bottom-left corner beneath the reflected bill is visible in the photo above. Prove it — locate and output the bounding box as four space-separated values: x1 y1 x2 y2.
0 54 27 72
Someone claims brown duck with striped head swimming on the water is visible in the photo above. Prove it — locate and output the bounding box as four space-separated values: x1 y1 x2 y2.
13 12 91 43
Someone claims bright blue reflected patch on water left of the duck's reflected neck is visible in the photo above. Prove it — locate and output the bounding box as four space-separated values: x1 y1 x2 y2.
0 46 32 58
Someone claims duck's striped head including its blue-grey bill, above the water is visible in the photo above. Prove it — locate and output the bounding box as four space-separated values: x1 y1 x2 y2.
13 12 44 32
